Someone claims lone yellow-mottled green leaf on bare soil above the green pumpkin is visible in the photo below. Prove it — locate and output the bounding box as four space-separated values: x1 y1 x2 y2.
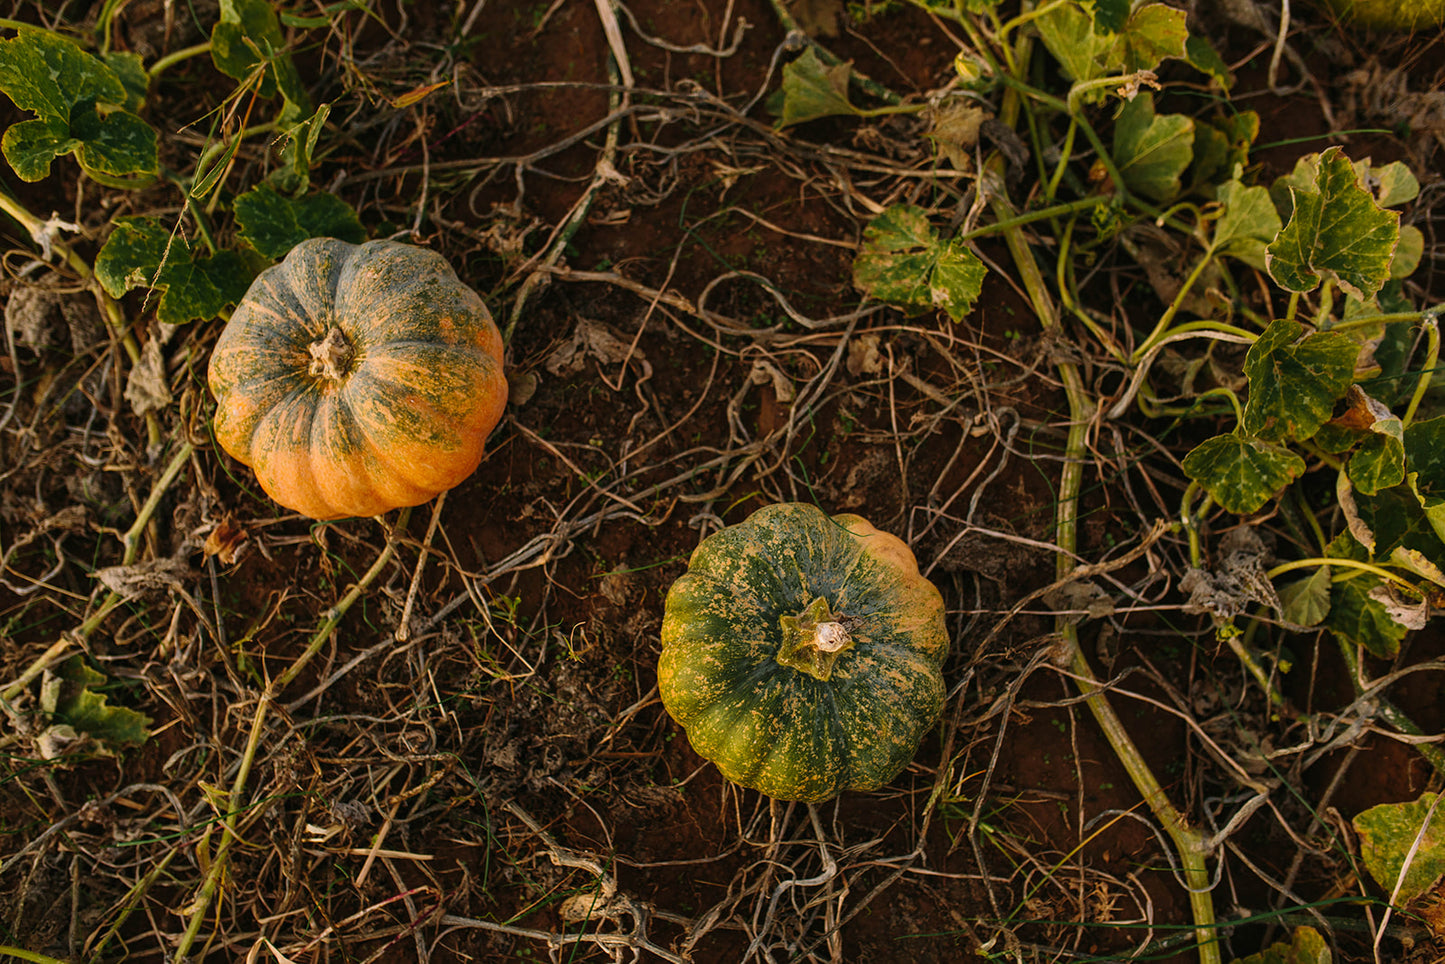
853 204 987 322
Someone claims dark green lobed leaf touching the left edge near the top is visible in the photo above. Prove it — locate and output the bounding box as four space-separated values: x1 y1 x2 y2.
0 27 159 180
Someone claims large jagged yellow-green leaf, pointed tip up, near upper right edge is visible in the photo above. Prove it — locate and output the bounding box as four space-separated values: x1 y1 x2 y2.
1266 147 1400 298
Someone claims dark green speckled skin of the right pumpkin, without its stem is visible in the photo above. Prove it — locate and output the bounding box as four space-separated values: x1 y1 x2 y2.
657 503 948 802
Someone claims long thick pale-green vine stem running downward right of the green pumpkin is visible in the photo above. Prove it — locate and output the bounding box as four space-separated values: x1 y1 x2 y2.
990 18 1221 964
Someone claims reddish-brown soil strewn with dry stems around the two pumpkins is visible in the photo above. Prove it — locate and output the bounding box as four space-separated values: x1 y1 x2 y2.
0 0 1445 964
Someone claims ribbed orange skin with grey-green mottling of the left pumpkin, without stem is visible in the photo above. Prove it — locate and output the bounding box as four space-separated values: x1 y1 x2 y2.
210 238 507 519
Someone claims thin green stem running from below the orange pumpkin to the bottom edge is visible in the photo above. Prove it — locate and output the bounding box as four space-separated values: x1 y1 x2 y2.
172 509 412 961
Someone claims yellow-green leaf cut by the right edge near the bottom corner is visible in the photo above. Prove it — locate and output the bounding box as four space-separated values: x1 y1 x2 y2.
1351 793 1445 908
